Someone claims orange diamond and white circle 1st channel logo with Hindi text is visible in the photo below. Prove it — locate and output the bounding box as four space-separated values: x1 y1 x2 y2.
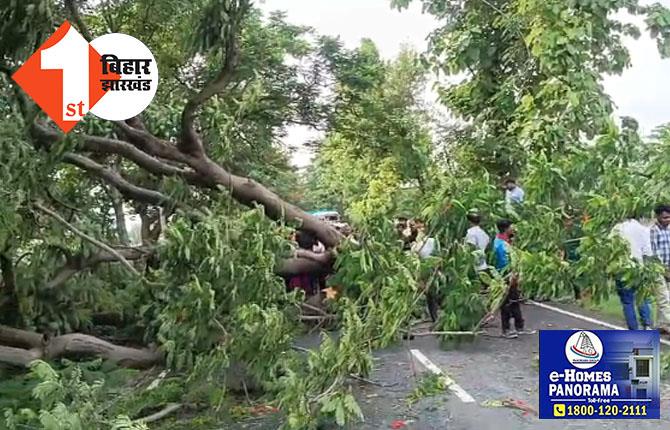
12 21 158 133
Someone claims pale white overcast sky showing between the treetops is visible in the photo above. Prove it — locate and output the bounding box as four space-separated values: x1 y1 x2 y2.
259 0 670 167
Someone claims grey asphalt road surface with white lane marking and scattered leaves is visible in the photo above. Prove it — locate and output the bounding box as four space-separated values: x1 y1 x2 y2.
232 304 670 430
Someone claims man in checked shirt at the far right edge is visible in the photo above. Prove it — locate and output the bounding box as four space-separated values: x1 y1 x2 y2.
651 204 670 334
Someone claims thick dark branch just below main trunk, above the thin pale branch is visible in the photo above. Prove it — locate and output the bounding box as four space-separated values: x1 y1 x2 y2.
63 152 172 205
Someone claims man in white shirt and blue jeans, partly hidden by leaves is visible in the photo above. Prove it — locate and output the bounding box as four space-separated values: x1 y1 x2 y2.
613 218 652 330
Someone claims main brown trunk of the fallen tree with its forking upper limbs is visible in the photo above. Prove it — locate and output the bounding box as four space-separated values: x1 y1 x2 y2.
23 4 342 252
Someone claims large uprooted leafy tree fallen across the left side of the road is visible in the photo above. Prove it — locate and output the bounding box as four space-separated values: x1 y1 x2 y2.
0 0 430 428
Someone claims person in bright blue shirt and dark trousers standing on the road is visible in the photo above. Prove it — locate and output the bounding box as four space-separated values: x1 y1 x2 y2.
493 219 531 339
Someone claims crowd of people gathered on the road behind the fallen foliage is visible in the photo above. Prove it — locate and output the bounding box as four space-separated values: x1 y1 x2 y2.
287 178 670 338
